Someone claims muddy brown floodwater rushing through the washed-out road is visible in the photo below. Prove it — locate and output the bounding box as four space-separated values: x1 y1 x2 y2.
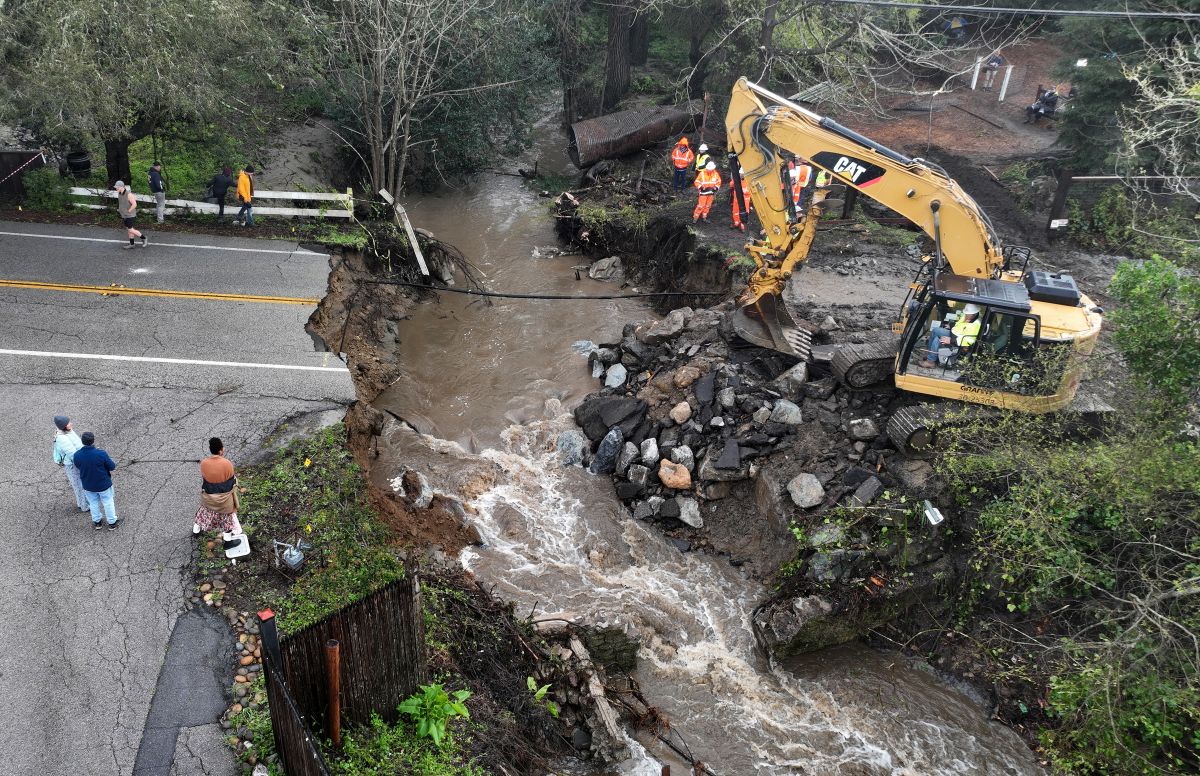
376 115 1039 776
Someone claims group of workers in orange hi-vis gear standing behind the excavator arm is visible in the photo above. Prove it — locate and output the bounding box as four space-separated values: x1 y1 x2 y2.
671 137 829 231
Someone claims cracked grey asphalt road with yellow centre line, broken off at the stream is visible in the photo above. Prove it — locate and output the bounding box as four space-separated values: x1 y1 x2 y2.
0 222 354 776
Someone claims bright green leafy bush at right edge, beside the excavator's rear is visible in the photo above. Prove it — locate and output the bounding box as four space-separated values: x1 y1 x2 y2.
1109 255 1200 402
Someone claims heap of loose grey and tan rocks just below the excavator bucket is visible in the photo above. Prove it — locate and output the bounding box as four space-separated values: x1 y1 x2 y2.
559 307 816 528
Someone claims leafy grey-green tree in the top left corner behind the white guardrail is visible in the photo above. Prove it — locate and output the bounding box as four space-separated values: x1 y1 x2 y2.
0 0 280 181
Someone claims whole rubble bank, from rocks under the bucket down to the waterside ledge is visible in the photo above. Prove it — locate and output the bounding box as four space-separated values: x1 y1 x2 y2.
558 303 947 652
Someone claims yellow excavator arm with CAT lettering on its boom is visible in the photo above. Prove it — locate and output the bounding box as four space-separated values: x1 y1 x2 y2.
725 78 1003 355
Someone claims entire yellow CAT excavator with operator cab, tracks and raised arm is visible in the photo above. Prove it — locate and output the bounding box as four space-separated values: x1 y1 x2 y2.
725 78 1103 453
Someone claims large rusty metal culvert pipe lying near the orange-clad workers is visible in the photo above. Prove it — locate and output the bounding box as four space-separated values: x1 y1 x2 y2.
568 100 704 169
